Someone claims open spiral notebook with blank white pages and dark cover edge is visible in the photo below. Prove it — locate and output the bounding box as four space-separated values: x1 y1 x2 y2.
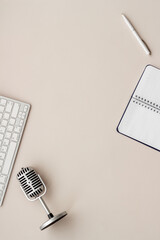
117 65 160 151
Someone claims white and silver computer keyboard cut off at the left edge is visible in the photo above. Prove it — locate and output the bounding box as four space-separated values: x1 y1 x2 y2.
0 96 30 206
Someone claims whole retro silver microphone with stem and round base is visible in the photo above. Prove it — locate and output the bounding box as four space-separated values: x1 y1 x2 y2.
17 167 67 230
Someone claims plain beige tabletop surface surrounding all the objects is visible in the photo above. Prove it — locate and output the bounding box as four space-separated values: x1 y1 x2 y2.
0 0 160 240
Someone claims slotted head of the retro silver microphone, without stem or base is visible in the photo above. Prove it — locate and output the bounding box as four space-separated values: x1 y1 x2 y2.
17 167 45 200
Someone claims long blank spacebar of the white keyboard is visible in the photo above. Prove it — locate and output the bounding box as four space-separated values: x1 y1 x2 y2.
2 142 17 175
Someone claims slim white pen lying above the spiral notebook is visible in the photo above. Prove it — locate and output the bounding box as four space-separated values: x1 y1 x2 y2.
122 14 151 55
